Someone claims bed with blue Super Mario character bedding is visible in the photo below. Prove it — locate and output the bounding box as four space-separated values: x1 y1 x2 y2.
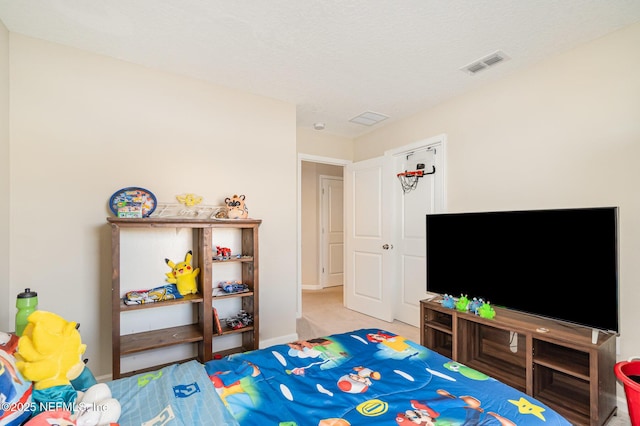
108 329 570 426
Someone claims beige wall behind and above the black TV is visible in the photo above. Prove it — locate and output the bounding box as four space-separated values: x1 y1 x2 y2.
354 20 640 380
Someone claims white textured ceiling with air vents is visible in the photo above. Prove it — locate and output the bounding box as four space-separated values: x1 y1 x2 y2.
0 0 640 137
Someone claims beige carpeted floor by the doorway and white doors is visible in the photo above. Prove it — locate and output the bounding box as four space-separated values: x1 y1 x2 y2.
297 286 631 426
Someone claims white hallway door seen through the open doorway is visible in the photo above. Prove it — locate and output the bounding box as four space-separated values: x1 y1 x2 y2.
320 176 344 288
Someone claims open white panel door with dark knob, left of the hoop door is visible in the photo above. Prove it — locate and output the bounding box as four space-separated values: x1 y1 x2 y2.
344 157 394 321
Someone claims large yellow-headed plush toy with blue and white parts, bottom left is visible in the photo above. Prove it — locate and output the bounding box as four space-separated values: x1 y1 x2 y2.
16 311 121 426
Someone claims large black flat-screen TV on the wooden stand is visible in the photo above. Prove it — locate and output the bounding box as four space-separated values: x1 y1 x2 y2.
426 207 619 333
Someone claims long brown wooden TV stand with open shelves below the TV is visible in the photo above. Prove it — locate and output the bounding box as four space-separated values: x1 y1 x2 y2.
420 300 617 426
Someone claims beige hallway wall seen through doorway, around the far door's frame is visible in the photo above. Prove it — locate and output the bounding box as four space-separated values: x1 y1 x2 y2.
300 161 343 287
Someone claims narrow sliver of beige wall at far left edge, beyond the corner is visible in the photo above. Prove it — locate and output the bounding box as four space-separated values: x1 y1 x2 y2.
0 21 8 330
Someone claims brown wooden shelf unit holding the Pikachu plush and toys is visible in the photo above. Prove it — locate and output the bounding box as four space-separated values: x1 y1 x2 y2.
107 217 262 379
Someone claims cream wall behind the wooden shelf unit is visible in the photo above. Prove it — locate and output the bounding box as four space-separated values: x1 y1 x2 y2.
0 33 297 375
